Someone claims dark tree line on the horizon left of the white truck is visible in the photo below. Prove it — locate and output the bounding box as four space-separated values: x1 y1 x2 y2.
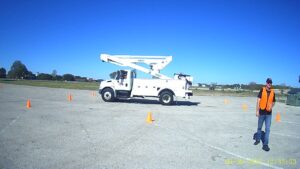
0 60 99 82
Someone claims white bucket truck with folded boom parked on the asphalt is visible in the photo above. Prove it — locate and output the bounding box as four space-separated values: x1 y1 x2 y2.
99 54 193 105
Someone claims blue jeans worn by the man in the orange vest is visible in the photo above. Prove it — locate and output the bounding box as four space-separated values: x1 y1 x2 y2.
256 115 272 145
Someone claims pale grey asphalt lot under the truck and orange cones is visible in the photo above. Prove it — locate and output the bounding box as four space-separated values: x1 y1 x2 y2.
0 83 300 169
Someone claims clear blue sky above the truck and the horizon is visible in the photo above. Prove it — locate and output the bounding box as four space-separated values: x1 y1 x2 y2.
0 0 300 87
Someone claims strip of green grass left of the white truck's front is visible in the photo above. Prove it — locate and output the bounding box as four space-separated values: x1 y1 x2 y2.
0 79 99 90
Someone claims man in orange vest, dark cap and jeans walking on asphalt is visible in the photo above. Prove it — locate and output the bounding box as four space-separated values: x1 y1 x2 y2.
254 78 275 151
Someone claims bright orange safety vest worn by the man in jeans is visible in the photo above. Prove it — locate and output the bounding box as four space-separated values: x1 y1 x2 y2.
259 87 274 111
